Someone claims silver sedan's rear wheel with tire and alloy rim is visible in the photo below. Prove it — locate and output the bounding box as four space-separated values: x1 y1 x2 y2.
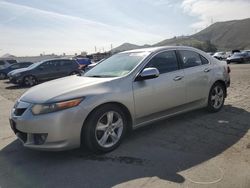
207 82 226 112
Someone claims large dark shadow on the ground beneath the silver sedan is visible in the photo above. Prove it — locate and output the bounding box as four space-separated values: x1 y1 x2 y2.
0 105 250 188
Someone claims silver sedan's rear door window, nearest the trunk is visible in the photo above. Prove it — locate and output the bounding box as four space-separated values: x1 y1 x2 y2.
179 50 202 68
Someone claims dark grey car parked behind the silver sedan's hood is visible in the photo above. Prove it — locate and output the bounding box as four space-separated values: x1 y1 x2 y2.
8 59 79 86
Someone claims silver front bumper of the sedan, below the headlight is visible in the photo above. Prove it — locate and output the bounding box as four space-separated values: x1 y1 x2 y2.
10 101 87 151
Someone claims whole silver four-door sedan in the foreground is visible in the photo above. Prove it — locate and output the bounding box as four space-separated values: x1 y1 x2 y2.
10 46 230 152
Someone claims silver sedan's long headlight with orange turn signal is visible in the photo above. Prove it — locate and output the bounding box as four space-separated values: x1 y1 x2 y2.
32 98 84 115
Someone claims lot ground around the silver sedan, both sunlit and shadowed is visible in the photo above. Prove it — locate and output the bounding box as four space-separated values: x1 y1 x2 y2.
0 64 250 188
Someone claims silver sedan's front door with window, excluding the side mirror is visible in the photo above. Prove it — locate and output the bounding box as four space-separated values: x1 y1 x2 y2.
133 50 186 123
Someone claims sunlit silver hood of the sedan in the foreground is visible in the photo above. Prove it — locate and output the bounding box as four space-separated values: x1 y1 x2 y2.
20 76 117 104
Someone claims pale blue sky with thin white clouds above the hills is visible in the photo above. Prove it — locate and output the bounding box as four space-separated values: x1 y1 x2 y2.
0 0 250 56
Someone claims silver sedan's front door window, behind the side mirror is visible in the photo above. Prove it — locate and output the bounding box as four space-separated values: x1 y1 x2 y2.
146 51 178 74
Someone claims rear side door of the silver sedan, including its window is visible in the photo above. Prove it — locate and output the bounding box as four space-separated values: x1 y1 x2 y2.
179 50 212 103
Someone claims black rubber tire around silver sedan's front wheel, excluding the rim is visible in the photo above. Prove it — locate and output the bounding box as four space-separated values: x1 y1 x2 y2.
81 104 128 154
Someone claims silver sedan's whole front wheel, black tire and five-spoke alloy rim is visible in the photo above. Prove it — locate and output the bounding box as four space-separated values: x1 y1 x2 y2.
81 104 128 154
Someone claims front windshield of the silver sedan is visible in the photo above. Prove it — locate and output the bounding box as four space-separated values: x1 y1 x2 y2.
84 52 149 77
